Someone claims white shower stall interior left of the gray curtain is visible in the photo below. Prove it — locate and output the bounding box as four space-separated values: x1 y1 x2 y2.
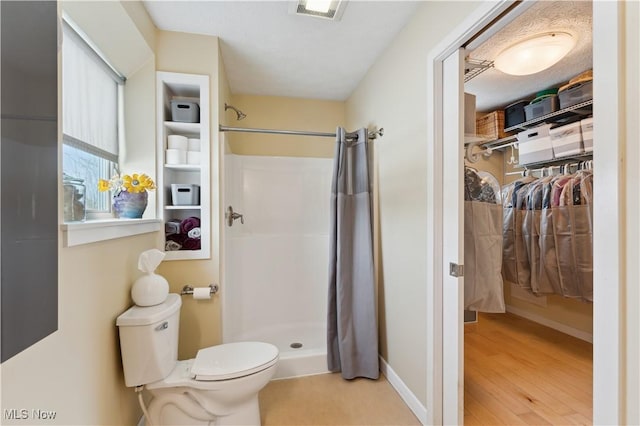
223 154 333 378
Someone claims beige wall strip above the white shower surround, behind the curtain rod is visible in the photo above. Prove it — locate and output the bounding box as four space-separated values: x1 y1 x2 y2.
227 95 344 158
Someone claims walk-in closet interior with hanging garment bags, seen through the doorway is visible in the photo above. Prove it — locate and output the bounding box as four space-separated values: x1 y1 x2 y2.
463 1 597 424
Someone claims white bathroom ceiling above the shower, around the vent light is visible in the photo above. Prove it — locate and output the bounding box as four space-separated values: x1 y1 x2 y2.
144 0 420 100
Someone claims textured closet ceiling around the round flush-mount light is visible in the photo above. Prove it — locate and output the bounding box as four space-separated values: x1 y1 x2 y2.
465 1 593 112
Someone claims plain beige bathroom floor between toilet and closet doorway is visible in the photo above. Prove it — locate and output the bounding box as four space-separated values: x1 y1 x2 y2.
260 373 420 426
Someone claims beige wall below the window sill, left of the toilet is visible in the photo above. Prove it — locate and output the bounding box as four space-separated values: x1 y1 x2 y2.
2 234 161 425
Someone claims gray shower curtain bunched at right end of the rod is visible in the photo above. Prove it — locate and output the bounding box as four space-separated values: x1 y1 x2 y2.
327 127 379 379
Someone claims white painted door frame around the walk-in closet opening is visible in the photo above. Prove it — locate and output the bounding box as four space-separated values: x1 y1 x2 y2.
426 0 627 424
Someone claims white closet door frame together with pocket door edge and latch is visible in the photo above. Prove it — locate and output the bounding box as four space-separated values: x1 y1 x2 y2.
429 2 624 424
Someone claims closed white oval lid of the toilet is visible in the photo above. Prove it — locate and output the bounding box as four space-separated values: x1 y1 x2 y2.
191 342 278 381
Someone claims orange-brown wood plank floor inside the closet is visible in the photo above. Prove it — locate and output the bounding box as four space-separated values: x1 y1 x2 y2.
464 313 593 425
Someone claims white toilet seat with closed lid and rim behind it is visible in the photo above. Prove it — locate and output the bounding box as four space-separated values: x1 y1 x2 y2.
145 342 278 390
